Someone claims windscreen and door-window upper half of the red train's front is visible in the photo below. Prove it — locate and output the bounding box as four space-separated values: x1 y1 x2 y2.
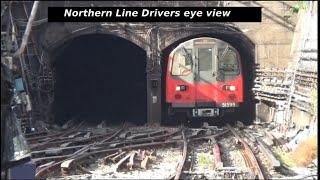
171 38 240 81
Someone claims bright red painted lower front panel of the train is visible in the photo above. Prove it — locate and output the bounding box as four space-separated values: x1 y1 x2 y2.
166 56 243 103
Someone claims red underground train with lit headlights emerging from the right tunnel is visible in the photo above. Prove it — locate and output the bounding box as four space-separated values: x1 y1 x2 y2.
166 37 243 119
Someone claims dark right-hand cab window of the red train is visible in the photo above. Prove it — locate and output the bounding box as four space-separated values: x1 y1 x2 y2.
218 47 240 75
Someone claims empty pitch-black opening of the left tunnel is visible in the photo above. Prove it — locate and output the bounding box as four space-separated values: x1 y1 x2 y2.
52 34 147 124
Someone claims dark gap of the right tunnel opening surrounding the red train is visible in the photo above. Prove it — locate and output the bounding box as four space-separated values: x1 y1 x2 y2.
161 33 256 125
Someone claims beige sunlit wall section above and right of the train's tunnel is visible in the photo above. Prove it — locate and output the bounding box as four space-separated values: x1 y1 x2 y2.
229 1 299 68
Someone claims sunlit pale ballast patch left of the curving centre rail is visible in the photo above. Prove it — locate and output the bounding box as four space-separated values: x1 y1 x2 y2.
50 148 182 179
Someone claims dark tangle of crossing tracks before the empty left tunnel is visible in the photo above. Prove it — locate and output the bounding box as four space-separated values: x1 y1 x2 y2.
29 122 185 178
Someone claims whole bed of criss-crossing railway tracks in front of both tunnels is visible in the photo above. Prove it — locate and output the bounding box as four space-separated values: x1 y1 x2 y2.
28 121 282 179
